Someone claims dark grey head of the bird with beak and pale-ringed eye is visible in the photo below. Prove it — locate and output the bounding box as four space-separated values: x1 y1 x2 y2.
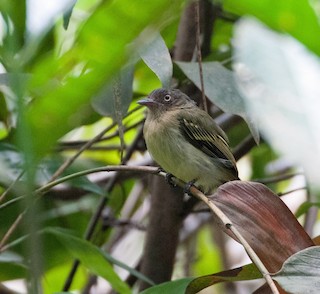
138 89 195 115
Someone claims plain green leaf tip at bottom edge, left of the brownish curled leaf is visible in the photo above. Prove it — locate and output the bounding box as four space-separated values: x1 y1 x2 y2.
140 278 192 294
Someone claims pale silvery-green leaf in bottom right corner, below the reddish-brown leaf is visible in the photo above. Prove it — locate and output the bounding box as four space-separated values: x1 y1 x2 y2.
272 246 320 294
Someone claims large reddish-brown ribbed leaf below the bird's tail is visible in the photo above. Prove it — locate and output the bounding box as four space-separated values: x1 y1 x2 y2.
211 181 314 272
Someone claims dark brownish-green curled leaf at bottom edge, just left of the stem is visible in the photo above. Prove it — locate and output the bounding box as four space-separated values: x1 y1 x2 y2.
186 263 262 294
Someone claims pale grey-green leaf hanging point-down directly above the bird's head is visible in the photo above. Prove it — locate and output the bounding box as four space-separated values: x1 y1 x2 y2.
140 34 173 88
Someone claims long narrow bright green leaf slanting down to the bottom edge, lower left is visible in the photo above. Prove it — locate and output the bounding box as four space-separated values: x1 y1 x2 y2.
43 228 131 293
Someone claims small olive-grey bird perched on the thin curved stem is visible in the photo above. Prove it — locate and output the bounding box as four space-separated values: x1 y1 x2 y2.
138 89 238 194
